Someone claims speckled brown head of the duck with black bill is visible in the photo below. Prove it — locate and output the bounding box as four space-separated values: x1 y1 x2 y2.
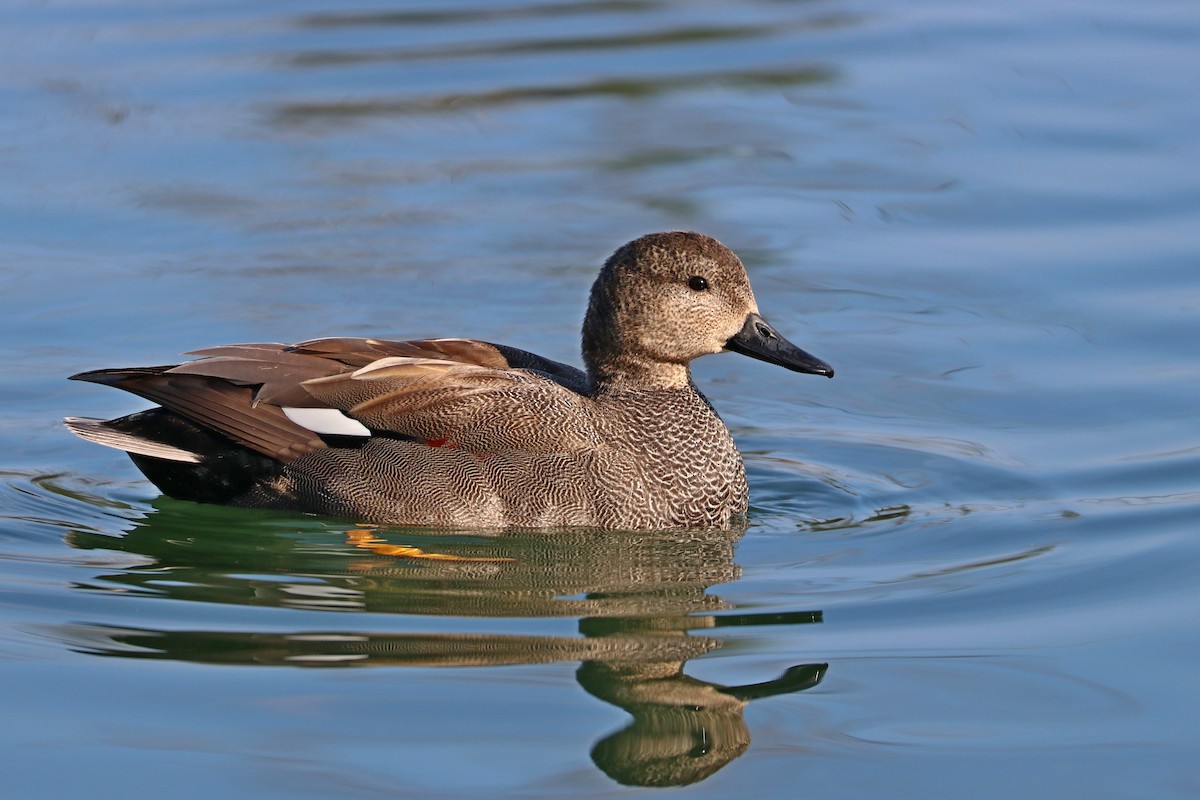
583 231 833 389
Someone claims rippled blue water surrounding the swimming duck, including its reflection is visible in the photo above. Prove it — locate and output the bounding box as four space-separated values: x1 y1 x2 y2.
0 0 1200 798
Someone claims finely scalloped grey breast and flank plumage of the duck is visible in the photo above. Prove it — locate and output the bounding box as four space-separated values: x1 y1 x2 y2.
248 386 746 529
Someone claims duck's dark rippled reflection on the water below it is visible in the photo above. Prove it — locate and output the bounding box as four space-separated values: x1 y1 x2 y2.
58 499 827 786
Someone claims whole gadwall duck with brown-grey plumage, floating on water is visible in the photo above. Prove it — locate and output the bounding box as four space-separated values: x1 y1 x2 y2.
66 231 833 530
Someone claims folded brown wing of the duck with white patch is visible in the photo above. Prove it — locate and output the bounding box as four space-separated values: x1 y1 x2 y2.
76 338 596 462
